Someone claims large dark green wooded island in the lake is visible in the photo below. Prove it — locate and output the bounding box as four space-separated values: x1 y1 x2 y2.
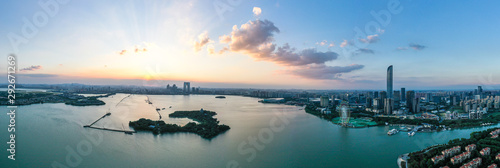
129 109 230 139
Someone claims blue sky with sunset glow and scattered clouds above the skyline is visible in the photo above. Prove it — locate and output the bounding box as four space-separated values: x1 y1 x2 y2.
0 0 500 90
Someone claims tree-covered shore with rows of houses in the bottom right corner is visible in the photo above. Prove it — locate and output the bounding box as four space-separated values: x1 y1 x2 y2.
398 128 500 168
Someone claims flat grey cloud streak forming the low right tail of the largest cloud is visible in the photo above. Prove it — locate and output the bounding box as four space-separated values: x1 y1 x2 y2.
288 64 364 79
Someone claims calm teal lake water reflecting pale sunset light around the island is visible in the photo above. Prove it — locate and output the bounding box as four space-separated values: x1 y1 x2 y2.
0 94 500 168
